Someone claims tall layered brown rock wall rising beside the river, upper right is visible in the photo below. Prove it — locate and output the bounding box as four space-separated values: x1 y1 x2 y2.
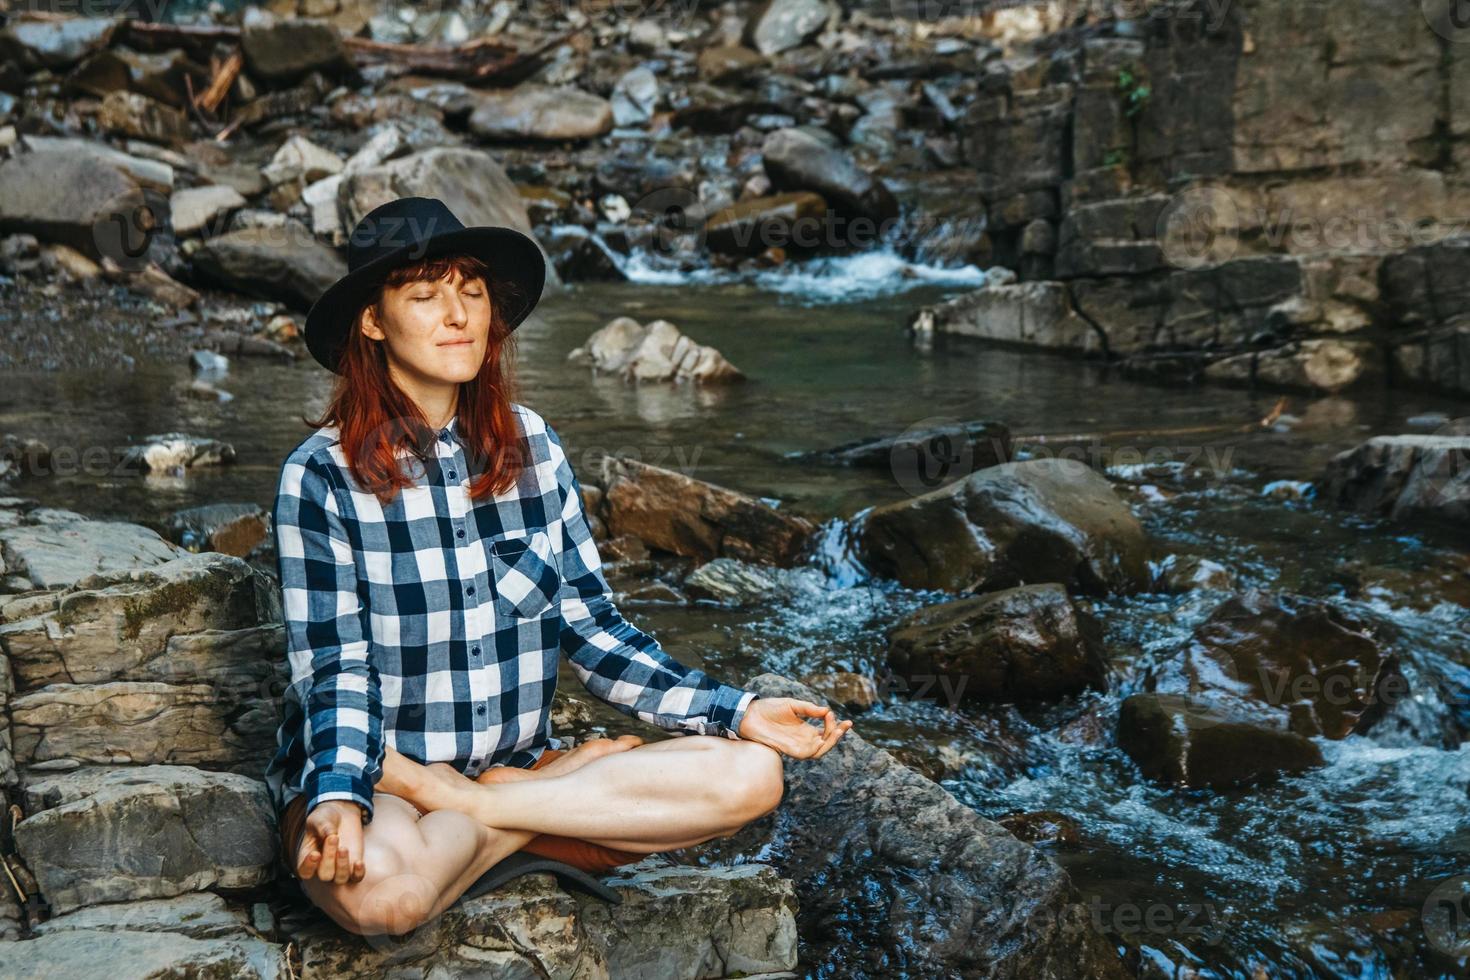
914 0 1470 392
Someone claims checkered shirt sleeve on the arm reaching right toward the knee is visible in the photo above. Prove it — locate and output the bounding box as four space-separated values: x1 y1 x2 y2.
545 425 759 739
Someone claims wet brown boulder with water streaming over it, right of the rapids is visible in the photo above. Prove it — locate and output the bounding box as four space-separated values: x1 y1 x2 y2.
1151 591 1407 739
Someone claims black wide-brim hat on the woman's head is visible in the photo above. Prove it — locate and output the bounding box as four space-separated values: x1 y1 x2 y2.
306 197 547 373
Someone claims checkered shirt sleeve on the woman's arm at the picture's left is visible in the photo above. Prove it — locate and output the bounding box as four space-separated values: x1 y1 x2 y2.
273 457 384 821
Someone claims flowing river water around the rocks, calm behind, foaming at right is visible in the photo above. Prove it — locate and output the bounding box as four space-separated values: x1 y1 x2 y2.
0 267 1470 977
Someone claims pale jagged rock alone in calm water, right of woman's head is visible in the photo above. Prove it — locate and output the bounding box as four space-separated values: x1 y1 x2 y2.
566 316 745 385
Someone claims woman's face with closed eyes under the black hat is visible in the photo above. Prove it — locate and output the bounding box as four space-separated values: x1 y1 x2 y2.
362 269 491 388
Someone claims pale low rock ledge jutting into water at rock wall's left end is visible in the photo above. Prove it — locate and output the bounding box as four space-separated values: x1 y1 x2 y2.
908 282 1105 354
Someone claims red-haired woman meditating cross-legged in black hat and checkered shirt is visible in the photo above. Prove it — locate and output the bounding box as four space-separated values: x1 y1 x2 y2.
266 197 851 934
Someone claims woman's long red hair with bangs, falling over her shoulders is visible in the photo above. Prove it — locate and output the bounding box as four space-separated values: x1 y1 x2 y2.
301 256 525 502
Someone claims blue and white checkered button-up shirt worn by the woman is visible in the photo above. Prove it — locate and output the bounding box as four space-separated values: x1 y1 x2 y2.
266 404 756 820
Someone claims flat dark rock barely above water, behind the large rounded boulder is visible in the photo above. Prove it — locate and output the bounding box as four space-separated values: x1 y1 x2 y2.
797 420 1011 488
